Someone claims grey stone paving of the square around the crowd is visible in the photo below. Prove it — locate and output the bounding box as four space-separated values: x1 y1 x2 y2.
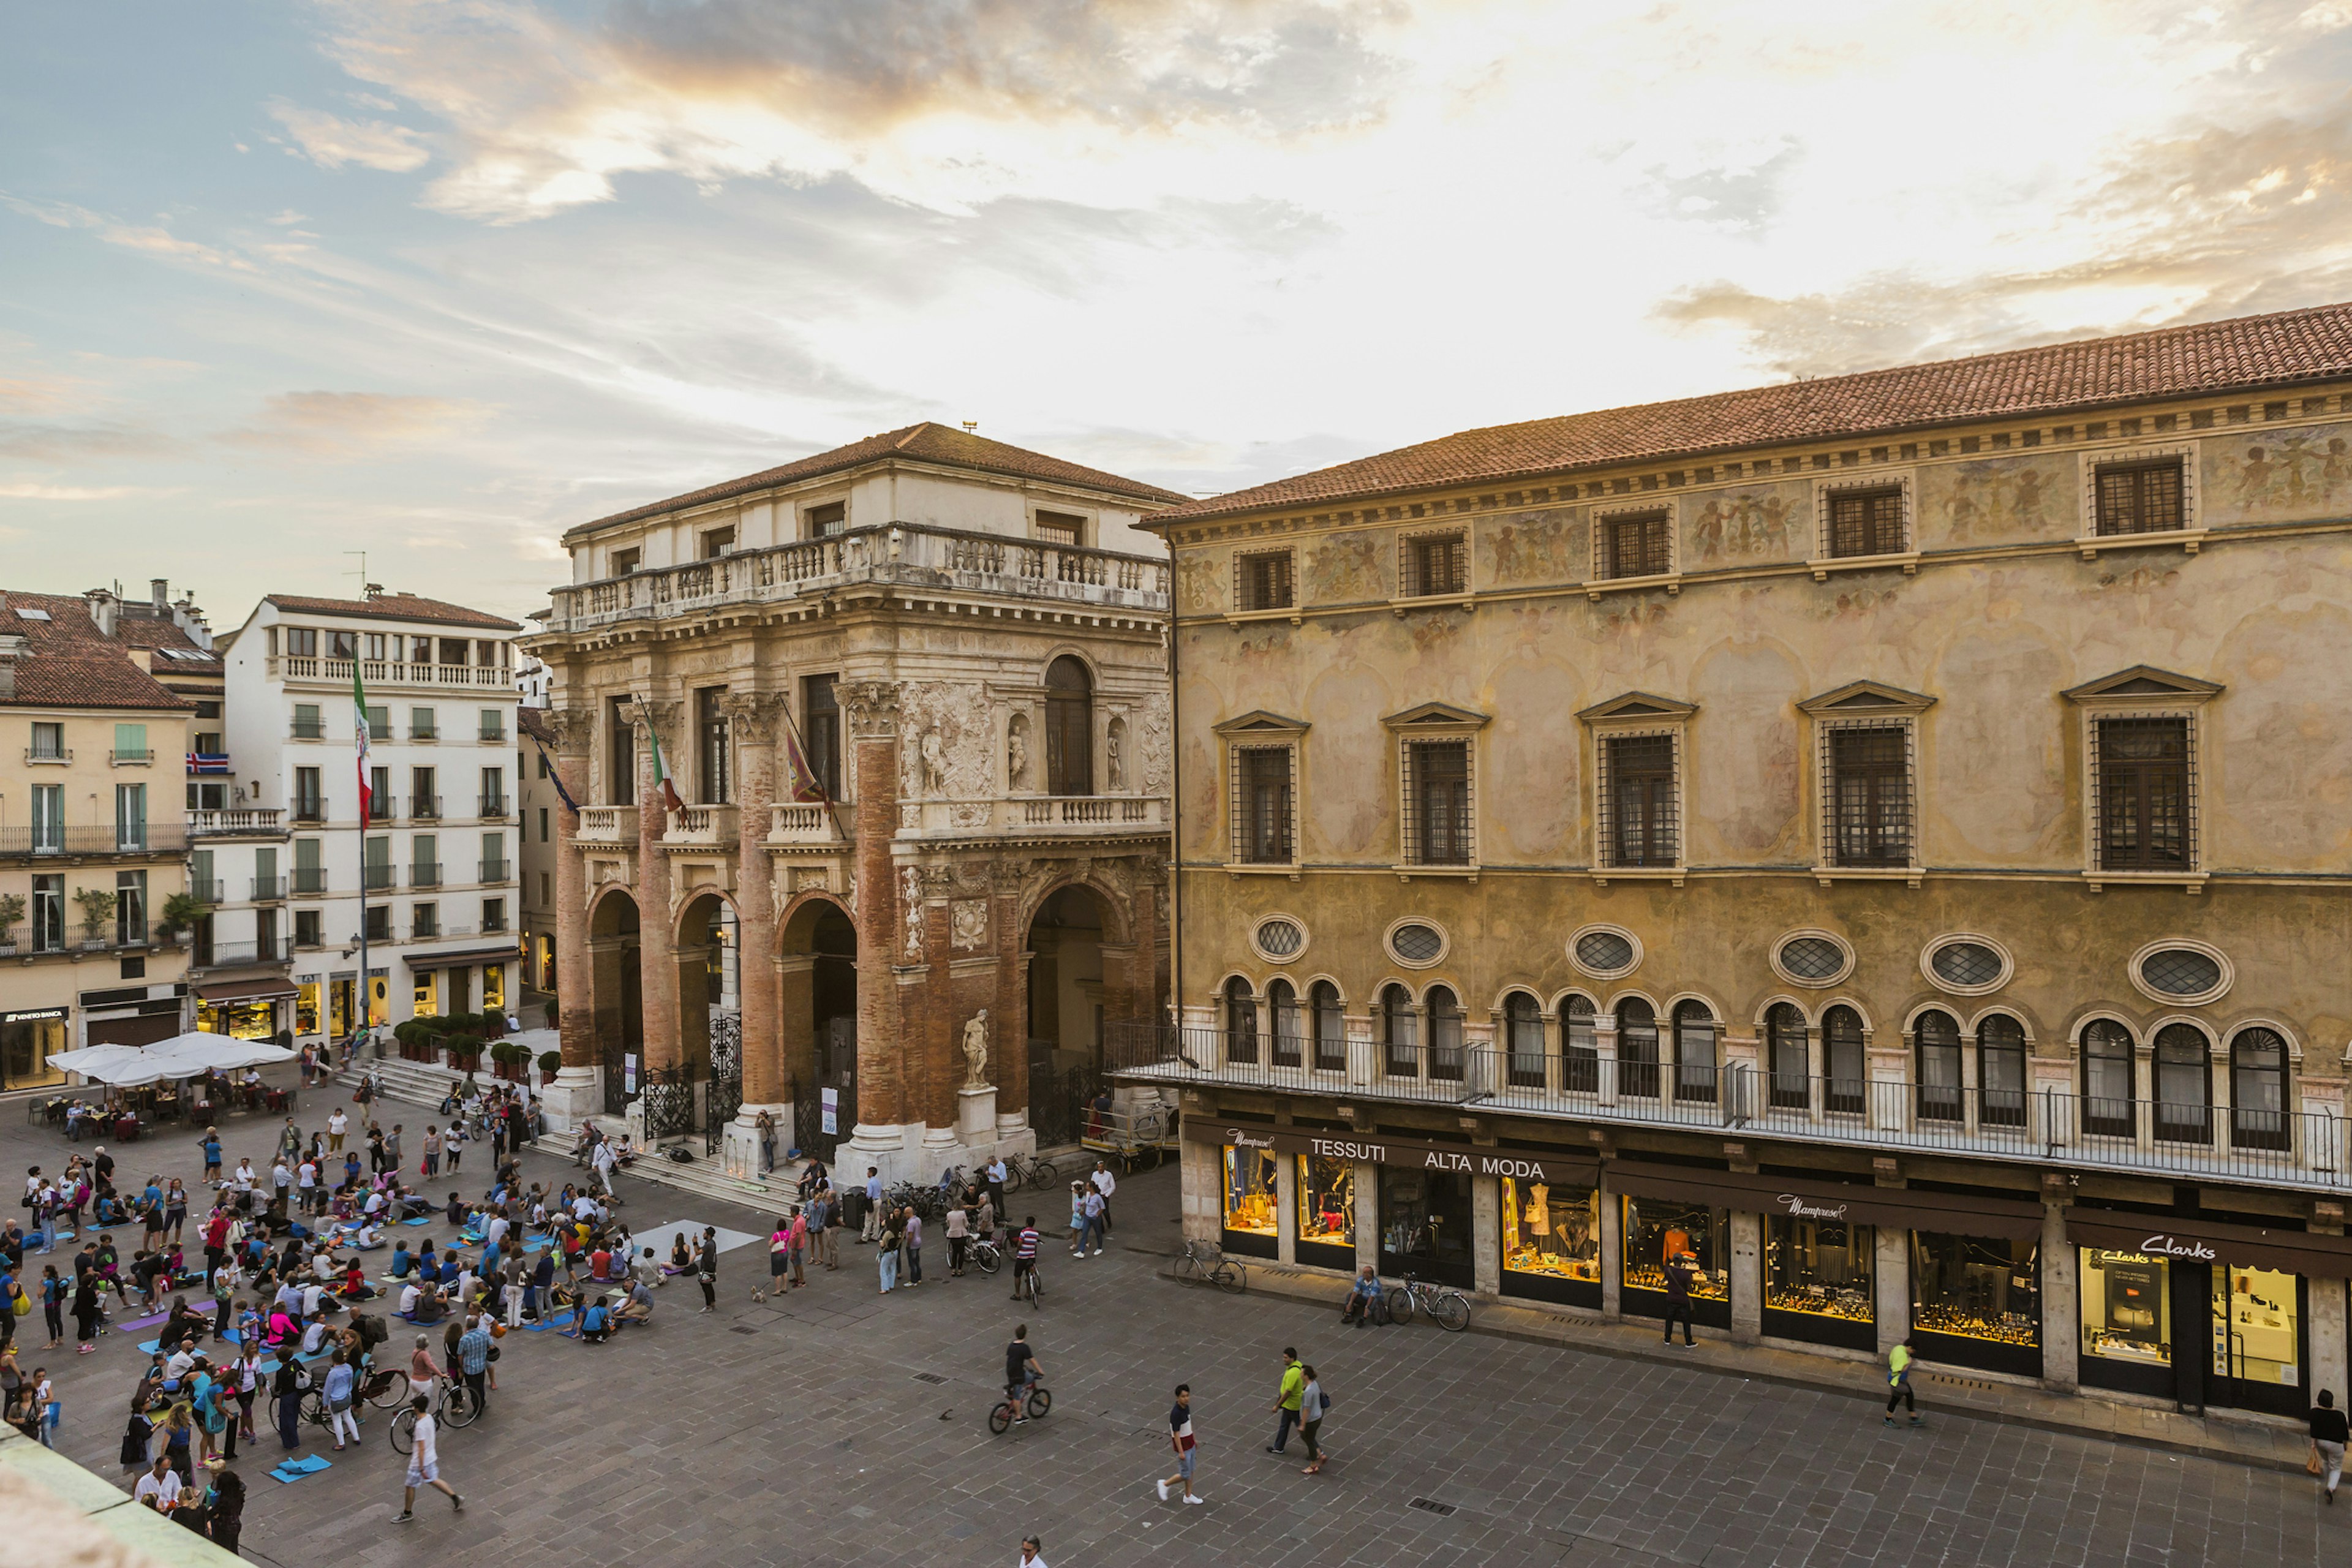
0 1100 2352 1568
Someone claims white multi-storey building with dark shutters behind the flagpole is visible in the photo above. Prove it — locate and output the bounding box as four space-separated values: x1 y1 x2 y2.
219 590 522 1039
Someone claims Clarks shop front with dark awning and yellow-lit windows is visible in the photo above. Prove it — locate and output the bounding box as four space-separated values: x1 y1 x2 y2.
2065 1208 2352 1415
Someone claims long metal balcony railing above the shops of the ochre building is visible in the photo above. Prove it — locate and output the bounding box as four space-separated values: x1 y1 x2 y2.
1106 1020 2352 1189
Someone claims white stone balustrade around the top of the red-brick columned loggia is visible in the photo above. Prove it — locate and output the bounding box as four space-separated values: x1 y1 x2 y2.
548 522 1169 632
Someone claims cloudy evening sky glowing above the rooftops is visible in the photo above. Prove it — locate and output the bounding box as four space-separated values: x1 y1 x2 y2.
0 0 2352 628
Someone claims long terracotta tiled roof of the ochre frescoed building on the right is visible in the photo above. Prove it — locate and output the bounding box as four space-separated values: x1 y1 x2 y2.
1150 303 2352 527
